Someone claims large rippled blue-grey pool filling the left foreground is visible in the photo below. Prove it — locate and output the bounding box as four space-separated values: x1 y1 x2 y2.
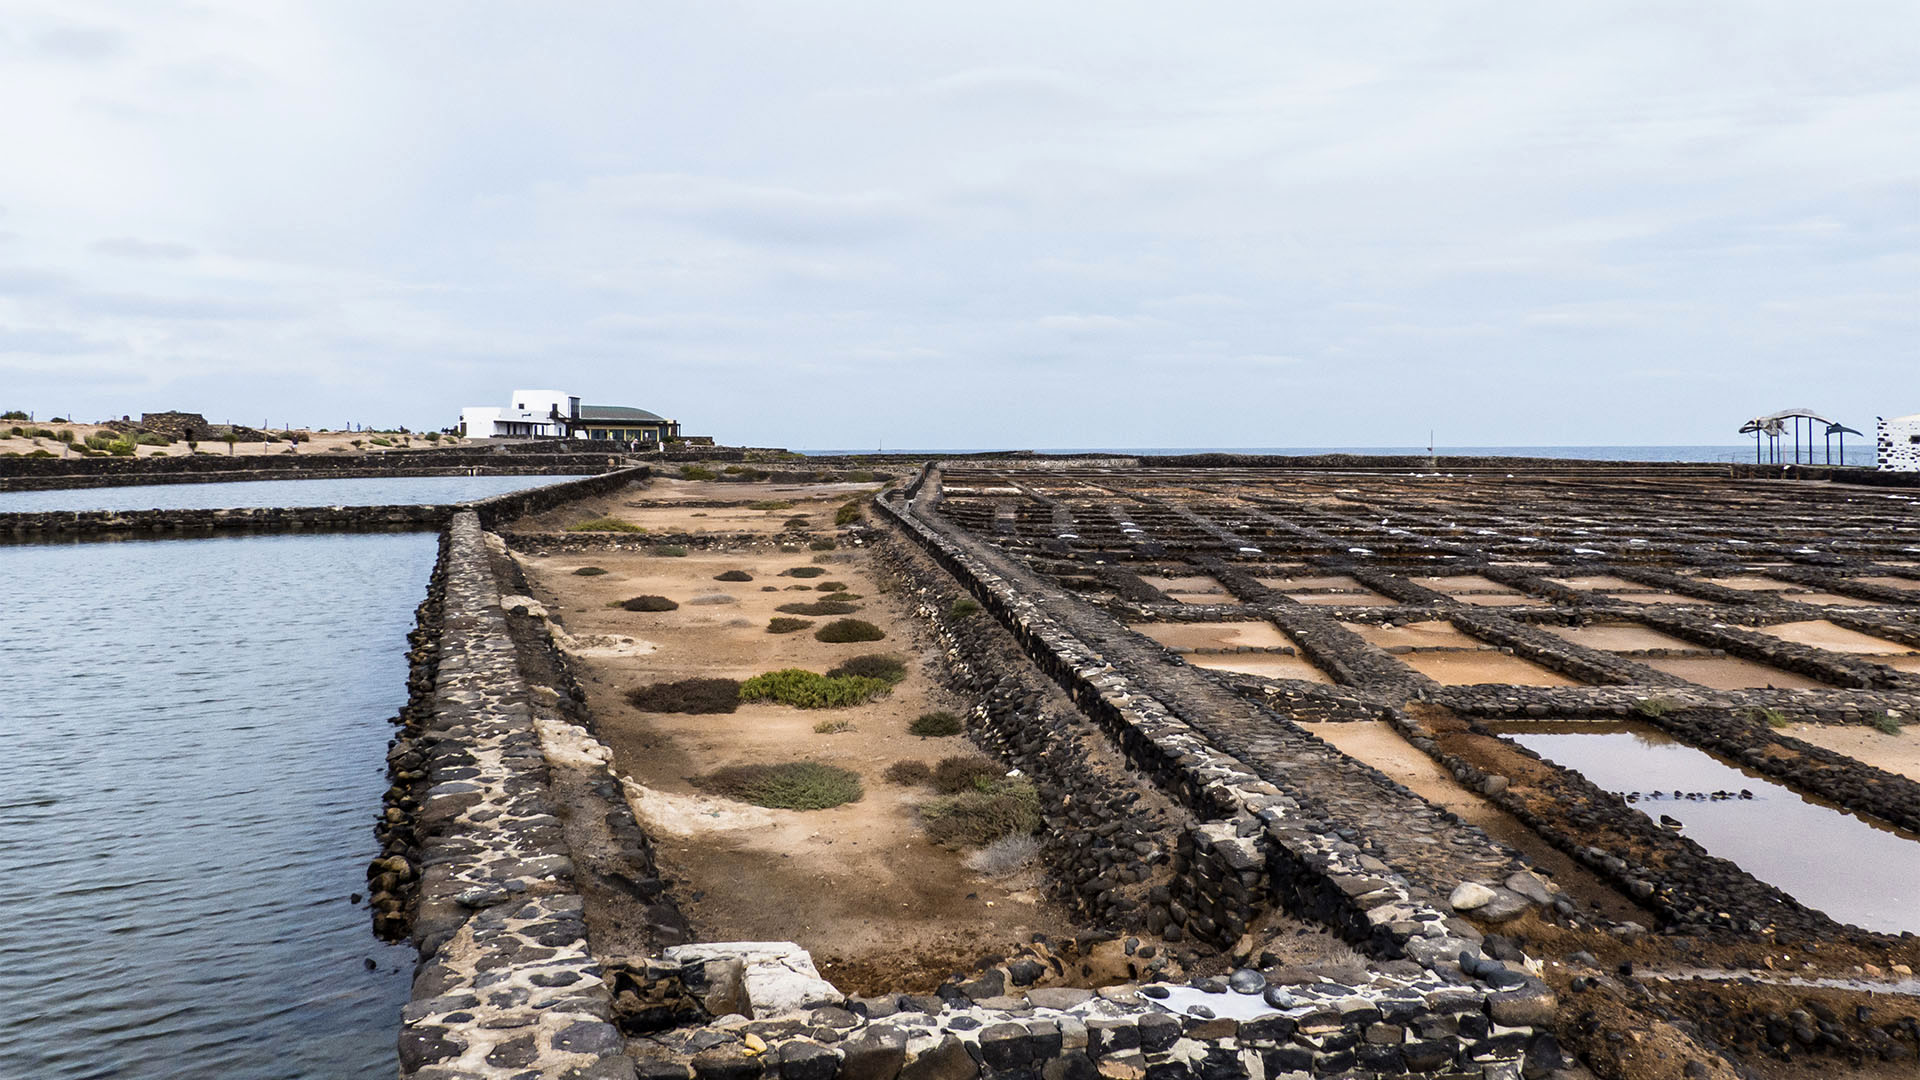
0 530 439 1080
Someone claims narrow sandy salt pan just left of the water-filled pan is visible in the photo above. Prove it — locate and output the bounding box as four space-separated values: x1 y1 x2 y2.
1300 721 1645 920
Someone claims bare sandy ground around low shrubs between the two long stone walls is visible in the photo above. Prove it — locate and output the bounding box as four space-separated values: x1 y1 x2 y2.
520 484 1071 990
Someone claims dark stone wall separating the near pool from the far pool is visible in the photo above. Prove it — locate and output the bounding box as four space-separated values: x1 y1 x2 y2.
0 465 649 540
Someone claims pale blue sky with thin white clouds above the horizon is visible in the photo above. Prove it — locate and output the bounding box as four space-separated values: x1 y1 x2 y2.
0 0 1920 450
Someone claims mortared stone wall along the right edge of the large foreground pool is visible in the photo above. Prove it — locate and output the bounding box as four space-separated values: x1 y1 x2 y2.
382 511 634 1080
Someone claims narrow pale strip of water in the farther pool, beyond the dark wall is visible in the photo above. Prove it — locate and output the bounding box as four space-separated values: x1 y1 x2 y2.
0 477 578 513
